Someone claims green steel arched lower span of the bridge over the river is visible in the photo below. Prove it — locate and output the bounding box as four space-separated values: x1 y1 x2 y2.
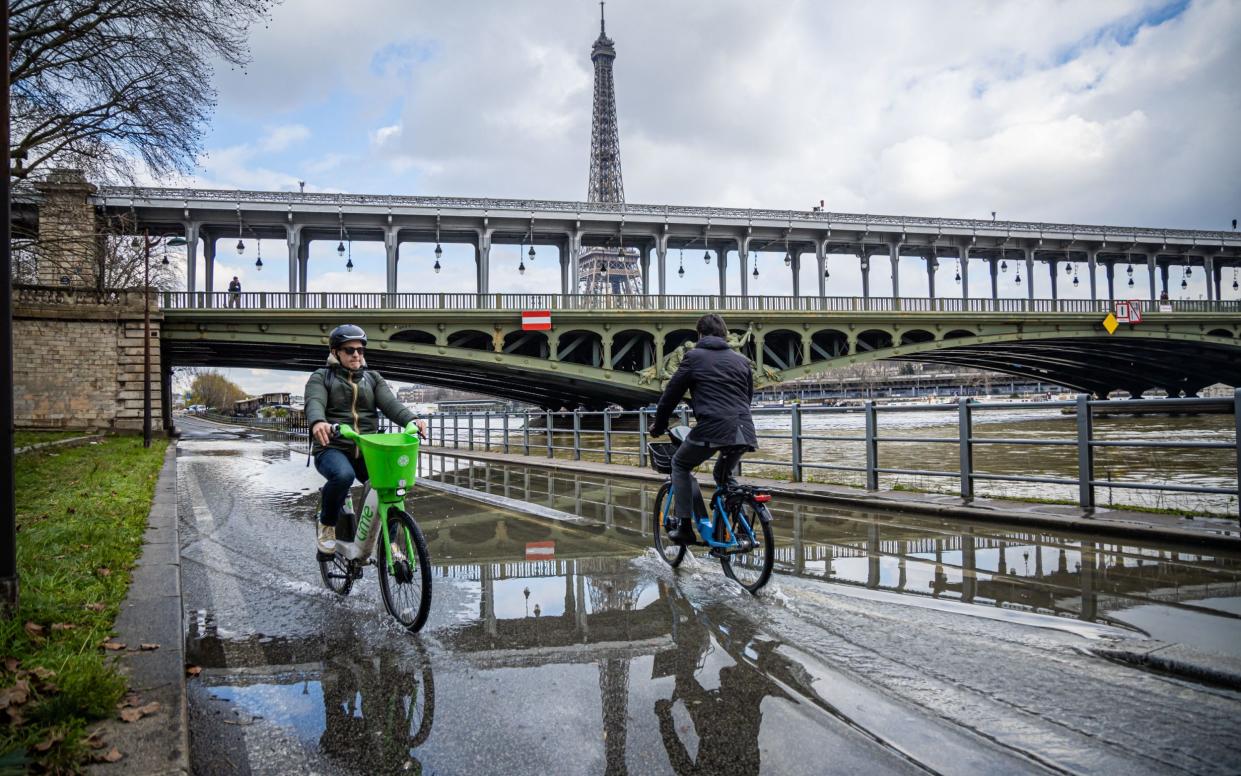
161 293 1241 407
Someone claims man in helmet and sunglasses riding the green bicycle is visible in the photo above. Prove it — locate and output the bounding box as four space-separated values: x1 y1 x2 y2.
305 324 426 553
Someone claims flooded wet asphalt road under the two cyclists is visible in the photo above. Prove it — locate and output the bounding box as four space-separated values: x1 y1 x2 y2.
177 418 1241 775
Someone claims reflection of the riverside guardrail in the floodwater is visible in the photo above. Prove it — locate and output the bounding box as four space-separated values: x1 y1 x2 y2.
422 454 1241 641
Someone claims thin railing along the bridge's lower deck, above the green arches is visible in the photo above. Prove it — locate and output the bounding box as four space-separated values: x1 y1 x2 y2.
160 291 1241 314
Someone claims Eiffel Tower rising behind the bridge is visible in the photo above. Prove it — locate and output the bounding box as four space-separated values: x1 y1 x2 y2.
577 2 643 294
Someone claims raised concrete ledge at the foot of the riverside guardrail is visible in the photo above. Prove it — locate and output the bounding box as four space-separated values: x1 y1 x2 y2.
422 444 1241 550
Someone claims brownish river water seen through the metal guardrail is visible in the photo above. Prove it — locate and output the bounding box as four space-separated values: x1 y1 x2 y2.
432 404 1237 515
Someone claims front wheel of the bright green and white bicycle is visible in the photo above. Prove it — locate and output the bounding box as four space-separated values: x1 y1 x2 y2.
376 507 431 633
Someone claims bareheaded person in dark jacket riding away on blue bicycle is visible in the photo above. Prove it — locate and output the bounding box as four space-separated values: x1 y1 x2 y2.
650 313 758 544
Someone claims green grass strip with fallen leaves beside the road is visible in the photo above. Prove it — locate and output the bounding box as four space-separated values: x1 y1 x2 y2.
0 437 168 772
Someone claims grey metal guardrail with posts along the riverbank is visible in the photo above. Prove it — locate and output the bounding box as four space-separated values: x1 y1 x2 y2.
423 389 1241 518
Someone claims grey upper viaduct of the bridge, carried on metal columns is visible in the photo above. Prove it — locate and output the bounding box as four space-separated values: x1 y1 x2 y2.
14 178 1241 300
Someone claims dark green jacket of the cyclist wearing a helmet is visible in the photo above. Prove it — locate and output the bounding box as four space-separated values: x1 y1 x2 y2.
305 355 413 456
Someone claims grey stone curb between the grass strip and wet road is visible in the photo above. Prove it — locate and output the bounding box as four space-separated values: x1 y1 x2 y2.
88 441 190 776
